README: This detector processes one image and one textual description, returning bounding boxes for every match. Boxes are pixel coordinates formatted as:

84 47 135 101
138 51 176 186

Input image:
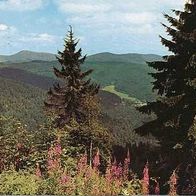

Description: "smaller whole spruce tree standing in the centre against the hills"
45 27 99 127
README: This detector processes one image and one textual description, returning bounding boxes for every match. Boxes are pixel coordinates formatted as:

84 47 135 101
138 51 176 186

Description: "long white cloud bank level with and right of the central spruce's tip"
68 12 160 36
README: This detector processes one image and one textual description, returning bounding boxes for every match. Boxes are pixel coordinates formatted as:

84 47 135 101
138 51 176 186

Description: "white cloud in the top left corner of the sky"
0 0 43 11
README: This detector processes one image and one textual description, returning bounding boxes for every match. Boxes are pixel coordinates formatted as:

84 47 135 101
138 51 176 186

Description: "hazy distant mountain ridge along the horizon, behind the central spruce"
0 50 161 64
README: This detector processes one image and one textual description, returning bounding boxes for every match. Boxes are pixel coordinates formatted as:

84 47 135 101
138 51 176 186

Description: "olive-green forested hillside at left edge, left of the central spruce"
0 77 46 130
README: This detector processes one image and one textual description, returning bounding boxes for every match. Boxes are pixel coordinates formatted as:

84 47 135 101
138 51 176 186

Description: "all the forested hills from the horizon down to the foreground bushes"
0 51 158 145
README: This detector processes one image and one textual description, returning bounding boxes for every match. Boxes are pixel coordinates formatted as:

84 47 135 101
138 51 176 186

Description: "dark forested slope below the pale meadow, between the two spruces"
102 96 157 147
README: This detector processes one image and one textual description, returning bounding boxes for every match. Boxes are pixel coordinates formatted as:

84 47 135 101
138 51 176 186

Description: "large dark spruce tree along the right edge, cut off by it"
137 0 196 193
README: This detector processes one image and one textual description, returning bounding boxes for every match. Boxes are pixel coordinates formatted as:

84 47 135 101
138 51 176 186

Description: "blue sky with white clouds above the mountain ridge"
0 0 185 55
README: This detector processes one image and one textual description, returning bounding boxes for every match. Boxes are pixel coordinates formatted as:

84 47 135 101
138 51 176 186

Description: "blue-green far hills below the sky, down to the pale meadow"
0 51 161 102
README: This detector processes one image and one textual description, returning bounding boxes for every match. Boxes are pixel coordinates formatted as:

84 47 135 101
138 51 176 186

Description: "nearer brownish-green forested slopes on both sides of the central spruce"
0 74 154 145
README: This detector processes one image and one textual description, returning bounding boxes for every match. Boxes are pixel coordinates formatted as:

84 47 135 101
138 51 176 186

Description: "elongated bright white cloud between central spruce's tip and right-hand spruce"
69 12 159 33
